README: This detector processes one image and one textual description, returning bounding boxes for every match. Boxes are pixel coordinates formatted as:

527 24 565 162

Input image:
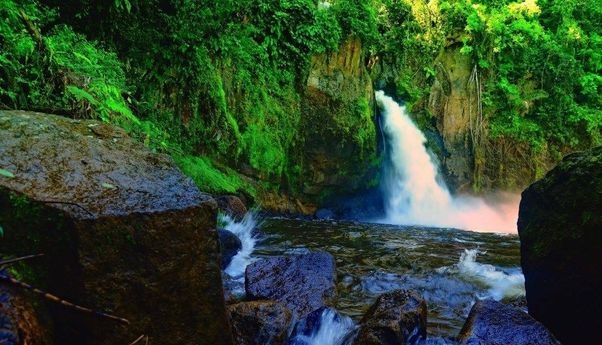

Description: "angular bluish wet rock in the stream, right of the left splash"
245 252 336 318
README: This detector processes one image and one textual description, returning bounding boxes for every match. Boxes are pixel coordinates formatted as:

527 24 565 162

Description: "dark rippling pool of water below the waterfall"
253 219 524 338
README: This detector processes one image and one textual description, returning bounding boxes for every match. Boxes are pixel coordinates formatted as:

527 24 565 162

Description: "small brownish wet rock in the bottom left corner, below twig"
0 271 53 345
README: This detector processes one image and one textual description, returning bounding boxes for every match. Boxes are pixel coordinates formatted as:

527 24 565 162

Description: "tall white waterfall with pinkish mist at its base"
376 91 518 232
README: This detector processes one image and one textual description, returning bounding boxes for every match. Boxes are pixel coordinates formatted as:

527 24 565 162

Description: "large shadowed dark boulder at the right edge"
518 147 602 344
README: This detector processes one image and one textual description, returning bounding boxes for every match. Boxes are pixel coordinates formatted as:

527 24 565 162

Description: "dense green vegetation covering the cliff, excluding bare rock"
0 0 602 199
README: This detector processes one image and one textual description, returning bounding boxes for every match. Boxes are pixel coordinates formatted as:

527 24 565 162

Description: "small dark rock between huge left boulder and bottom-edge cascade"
228 301 292 345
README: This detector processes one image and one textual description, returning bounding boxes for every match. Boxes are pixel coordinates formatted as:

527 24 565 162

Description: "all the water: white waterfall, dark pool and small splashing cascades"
221 91 525 345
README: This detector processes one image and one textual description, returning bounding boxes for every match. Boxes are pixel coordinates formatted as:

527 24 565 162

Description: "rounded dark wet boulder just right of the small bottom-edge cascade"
354 290 427 345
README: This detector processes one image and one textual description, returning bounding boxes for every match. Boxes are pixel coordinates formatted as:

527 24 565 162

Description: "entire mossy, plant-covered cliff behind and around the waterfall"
0 0 602 213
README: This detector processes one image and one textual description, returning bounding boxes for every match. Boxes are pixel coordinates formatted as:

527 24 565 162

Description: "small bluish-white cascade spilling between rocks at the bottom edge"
286 307 355 345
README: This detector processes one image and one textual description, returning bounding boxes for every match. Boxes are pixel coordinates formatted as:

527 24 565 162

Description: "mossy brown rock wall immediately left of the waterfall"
299 37 377 200
